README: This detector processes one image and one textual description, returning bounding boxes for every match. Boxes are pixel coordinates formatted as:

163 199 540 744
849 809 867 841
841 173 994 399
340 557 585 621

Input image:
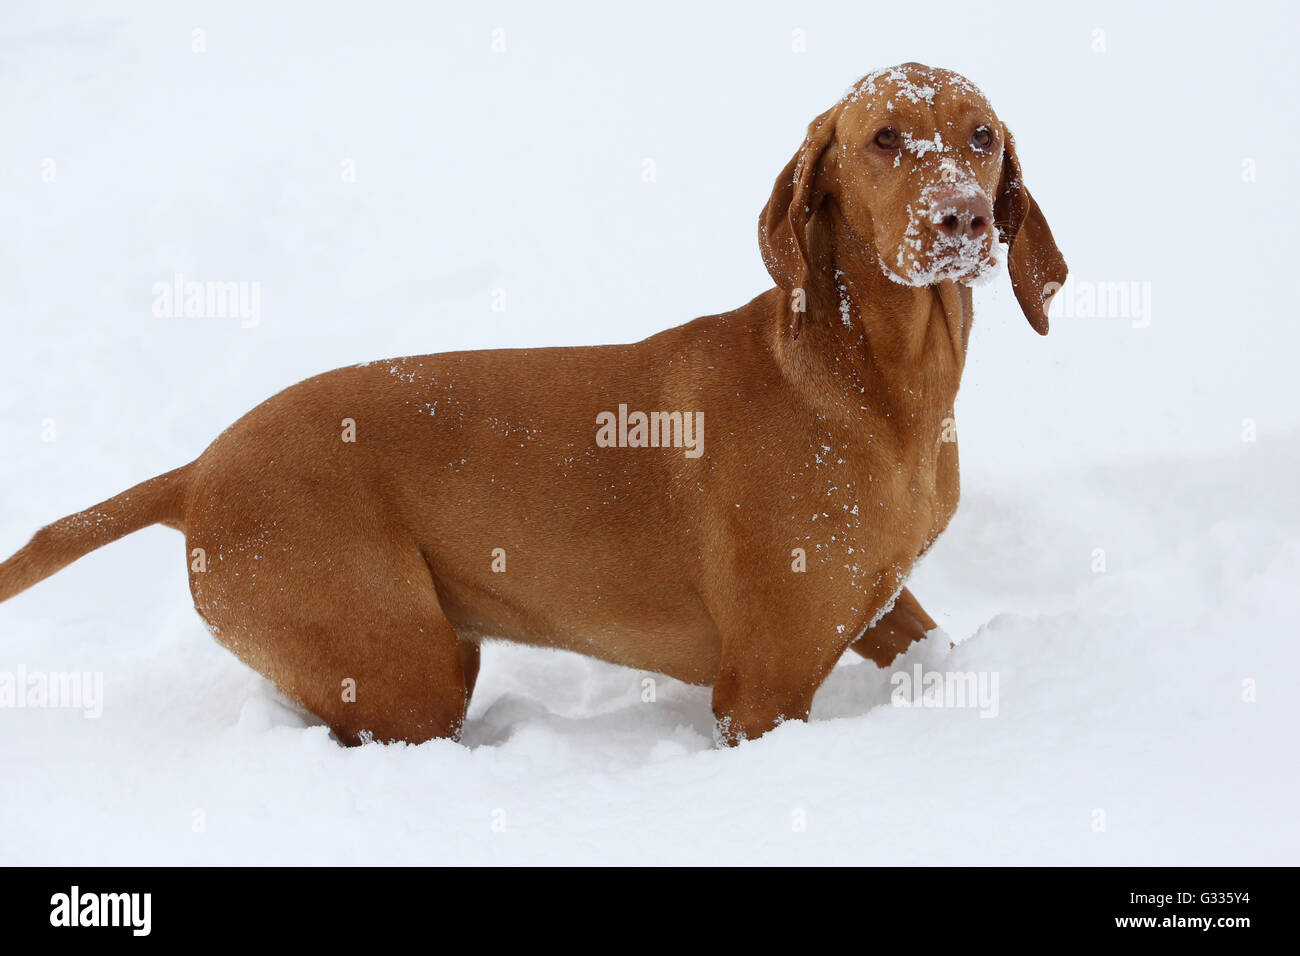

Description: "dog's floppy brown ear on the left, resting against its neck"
758 104 840 337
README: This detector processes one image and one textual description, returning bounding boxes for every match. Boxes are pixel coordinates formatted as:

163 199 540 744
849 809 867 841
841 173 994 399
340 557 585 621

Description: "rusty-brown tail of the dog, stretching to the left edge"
0 464 191 601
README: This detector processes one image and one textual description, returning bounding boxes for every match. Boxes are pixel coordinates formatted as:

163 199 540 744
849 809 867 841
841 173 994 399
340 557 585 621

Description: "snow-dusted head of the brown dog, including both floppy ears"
758 64 1066 334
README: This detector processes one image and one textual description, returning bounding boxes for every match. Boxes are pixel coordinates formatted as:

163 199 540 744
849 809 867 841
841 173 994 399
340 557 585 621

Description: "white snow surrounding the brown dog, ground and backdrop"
0 0 1300 865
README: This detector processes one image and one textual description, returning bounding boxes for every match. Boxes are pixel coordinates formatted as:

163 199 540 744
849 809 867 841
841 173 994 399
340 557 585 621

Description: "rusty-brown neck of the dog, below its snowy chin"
774 200 972 442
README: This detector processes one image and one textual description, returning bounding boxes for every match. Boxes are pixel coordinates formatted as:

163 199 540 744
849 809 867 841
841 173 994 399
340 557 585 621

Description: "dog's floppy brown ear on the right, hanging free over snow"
993 127 1070 336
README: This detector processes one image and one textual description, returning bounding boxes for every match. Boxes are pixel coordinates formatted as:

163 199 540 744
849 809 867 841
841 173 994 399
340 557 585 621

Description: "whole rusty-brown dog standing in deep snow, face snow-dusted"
0 64 1066 743
